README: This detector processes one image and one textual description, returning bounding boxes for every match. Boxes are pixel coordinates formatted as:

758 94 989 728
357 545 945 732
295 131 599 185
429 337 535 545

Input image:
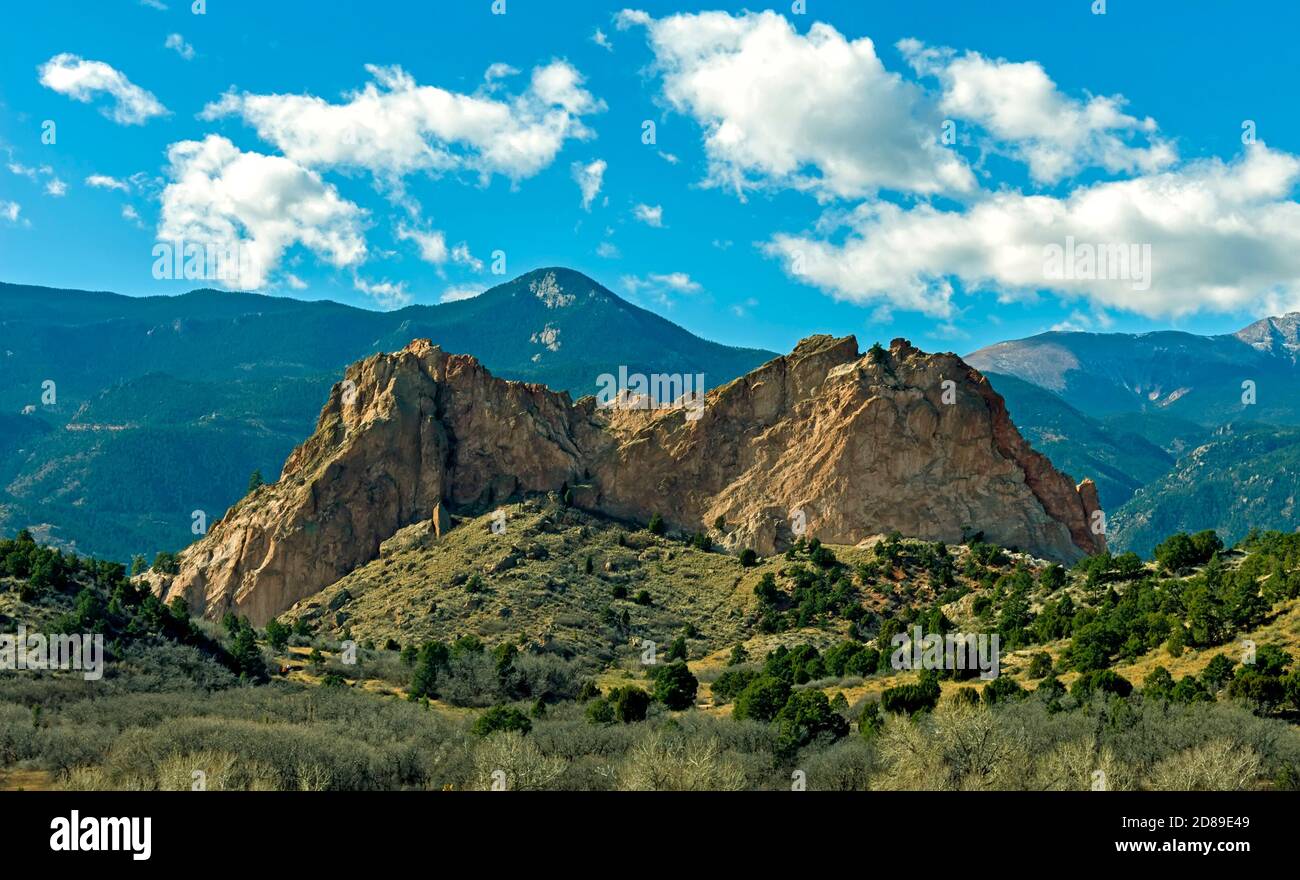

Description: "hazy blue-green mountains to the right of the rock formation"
966 312 1300 554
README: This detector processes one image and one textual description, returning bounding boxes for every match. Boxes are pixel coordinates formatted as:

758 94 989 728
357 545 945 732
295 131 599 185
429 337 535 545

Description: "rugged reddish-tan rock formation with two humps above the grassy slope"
151 337 1105 624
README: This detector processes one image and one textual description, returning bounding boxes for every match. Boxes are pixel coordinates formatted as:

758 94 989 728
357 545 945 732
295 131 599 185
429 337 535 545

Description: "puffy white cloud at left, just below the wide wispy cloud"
159 135 367 287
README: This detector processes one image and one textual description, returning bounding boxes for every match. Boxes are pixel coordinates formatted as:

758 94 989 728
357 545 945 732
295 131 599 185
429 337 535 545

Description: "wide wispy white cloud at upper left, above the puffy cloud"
202 61 605 185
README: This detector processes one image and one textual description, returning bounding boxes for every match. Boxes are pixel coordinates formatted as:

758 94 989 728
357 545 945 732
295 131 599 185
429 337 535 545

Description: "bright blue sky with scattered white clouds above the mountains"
0 0 1300 352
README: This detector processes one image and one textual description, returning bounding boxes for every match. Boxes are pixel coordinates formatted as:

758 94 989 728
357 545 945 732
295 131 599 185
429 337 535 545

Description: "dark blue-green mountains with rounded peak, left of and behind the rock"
0 268 775 559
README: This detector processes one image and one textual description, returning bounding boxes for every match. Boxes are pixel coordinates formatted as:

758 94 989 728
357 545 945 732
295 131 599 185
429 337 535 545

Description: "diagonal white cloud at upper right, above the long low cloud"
898 39 1178 183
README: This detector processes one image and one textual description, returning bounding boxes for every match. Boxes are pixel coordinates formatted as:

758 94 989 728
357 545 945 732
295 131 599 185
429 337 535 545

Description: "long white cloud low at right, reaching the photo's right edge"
764 144 1300 317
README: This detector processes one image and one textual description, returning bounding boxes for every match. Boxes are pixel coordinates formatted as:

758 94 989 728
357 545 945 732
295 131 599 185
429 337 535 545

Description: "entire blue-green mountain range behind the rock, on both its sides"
0 268 1300 559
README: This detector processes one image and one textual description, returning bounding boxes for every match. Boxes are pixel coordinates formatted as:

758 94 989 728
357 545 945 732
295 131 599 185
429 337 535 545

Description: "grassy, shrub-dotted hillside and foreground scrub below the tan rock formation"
10 499 1300 790
